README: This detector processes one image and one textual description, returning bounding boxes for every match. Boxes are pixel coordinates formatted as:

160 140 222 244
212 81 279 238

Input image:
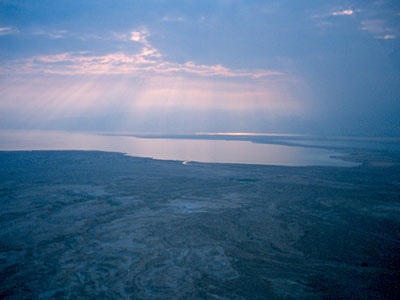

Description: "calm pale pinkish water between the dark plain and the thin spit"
0 130 355 166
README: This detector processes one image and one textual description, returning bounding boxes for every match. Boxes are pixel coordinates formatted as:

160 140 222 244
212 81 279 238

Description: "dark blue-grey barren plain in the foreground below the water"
0 151 400 300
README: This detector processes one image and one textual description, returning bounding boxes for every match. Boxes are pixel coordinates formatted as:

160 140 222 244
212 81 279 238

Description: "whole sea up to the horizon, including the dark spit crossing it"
0 130 400 167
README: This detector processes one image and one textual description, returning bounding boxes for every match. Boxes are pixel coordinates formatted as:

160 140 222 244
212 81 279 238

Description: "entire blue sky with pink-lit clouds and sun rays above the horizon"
0 0 400 136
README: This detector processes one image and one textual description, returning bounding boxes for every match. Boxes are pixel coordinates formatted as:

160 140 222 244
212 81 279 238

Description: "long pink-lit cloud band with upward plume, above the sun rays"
0 31 286 80
